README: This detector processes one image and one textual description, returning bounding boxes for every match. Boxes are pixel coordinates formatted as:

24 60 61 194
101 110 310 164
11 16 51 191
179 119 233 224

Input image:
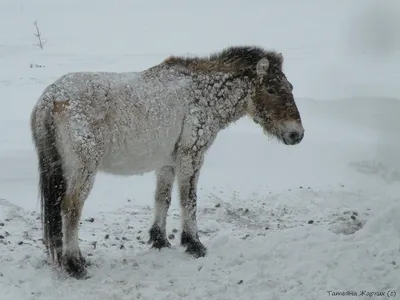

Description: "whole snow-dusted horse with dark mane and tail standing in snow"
31 47 304 278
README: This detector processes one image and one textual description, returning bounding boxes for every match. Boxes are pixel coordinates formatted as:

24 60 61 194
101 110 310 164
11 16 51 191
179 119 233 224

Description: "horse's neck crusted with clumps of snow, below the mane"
193 73 253 128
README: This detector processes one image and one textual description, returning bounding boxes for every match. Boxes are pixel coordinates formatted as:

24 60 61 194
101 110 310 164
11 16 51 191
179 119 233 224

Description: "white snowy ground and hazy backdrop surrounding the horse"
0 0 400 300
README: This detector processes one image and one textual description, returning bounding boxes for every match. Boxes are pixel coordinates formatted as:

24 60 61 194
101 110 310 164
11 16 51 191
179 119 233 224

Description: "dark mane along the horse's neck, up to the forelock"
164 46 282 77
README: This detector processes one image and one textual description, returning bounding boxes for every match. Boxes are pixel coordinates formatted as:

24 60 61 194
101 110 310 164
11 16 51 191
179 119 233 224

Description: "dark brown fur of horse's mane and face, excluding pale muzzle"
164 46 301 142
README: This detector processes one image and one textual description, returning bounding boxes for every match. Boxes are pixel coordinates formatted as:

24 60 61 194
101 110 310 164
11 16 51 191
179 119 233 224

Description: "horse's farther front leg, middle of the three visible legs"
149 166 175 249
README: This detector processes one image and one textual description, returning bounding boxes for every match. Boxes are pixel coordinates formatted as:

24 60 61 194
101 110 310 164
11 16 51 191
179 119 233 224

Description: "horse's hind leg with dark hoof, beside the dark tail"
61 126 103 278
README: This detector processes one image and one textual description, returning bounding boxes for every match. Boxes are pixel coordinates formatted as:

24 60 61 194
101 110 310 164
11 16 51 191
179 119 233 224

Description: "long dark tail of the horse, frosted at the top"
31 96 67 263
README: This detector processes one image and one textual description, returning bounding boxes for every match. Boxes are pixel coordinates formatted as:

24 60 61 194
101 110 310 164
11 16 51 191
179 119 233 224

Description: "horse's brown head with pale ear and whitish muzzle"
248 53 304 145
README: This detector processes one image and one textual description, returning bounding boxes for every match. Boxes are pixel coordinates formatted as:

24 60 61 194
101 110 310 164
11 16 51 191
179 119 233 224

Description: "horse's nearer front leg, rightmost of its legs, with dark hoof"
177 148 207 257
